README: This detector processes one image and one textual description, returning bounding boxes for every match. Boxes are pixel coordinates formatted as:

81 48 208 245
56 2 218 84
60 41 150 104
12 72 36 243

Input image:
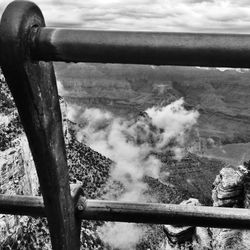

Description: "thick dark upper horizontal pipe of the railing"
31 28 250 68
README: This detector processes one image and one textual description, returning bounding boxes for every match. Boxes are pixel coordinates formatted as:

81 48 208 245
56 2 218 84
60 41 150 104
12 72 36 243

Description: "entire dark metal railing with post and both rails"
0 1 250 250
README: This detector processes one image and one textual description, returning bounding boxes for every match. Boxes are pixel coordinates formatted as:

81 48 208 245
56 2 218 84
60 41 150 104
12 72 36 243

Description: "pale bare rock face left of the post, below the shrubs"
0 135 39 241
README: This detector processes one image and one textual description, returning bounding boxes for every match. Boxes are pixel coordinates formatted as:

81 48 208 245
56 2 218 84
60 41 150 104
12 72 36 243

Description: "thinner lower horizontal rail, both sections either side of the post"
0 195 250 229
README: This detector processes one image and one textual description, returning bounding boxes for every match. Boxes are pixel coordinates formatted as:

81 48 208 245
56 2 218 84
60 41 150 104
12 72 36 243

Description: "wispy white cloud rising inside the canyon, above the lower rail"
72 99 199 201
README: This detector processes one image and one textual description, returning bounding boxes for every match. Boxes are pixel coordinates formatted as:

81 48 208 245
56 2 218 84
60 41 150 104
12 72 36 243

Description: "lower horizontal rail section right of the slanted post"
79 200 250 229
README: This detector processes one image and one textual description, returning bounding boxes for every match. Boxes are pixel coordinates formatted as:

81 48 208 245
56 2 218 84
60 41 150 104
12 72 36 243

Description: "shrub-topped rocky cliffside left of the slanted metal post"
0 69 39 243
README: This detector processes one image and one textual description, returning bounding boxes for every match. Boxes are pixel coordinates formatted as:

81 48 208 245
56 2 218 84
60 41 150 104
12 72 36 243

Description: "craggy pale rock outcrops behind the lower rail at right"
163 164 250 250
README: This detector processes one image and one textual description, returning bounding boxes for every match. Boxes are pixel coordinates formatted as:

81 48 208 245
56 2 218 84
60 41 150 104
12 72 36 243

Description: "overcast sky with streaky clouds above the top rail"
0 0 250 33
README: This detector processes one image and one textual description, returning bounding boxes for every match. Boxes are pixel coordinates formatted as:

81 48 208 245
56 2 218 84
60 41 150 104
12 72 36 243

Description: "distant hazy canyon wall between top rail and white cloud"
56 64 250 143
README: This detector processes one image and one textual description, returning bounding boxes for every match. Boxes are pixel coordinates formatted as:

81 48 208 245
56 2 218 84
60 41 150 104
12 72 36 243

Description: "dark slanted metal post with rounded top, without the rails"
0 1 80 250
